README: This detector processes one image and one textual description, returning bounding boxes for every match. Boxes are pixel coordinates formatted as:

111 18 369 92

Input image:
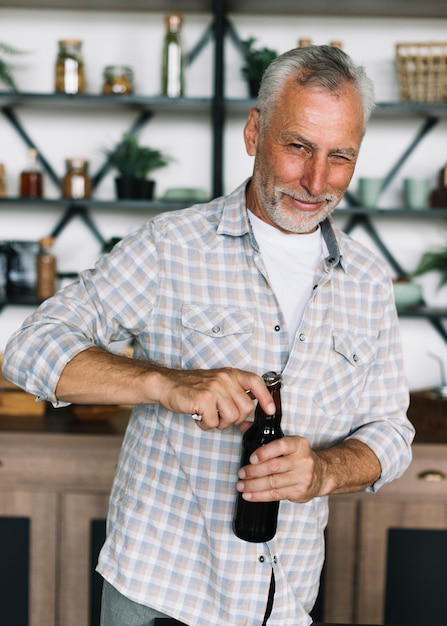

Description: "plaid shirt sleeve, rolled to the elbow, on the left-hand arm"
3 227 157 407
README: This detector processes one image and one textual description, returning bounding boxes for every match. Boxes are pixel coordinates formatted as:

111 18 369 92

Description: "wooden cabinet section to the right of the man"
324 444 447 626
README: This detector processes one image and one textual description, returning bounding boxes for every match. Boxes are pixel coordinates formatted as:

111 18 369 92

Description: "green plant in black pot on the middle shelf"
105 133 170 199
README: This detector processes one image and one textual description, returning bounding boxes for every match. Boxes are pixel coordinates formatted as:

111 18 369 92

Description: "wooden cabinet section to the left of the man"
0 410 128 626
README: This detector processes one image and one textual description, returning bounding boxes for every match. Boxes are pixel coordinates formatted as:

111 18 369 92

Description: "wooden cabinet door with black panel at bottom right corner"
354 496 447 624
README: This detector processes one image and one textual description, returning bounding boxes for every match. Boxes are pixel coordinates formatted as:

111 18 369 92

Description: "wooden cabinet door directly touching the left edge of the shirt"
58 493 109 626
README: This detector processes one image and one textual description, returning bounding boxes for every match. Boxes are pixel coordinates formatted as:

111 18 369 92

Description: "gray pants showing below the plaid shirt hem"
101 580 186 626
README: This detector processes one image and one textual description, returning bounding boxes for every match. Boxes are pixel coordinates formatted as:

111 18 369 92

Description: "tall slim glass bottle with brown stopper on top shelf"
161 13 184 98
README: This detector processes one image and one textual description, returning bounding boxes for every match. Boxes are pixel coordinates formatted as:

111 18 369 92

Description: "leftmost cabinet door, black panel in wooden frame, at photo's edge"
0 490 57 626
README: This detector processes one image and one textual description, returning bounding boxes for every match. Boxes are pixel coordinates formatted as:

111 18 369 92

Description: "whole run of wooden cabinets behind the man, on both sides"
0 401 447 626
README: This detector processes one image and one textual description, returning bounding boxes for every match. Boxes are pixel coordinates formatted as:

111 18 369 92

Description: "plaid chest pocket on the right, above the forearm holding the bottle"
314 334 377 415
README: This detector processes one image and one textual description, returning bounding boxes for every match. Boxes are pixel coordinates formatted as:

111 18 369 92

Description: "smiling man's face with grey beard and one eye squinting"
244 79 363 233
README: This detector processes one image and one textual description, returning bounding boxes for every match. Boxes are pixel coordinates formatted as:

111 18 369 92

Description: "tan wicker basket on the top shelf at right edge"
396 43 447 102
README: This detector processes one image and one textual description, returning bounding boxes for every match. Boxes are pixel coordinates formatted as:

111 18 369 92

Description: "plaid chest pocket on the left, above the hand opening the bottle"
182 305 253 369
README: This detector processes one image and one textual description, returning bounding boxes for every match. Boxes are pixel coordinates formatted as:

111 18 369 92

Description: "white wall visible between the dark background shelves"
0 9 447 389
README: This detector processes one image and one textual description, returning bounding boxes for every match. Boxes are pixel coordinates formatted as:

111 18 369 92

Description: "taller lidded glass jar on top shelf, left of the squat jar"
54 39 86 94
